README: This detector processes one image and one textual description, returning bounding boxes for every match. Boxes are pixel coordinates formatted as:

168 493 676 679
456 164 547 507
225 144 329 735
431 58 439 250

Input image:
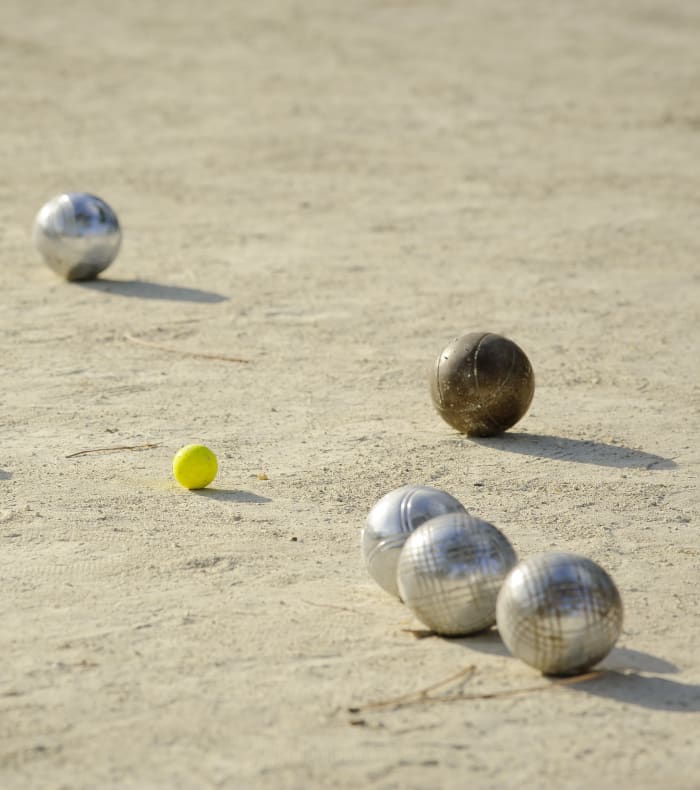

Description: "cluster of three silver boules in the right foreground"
362 486 622 675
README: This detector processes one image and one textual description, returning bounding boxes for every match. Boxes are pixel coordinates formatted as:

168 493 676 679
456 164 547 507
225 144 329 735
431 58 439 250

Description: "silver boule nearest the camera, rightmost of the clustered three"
496 552 622 675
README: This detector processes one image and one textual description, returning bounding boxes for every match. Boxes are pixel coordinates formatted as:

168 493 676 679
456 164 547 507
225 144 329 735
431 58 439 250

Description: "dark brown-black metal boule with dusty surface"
430 332 535 436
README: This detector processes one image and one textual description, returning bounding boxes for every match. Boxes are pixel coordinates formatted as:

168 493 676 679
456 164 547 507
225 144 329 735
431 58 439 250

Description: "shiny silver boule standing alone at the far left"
34 192 122 280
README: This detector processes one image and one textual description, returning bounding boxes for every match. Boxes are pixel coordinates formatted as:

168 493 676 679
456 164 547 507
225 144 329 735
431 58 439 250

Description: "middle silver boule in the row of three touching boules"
397 513 517 636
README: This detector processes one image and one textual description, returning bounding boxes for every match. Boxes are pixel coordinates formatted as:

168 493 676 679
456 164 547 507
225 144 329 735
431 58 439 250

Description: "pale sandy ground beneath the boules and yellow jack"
0 0 700 790
